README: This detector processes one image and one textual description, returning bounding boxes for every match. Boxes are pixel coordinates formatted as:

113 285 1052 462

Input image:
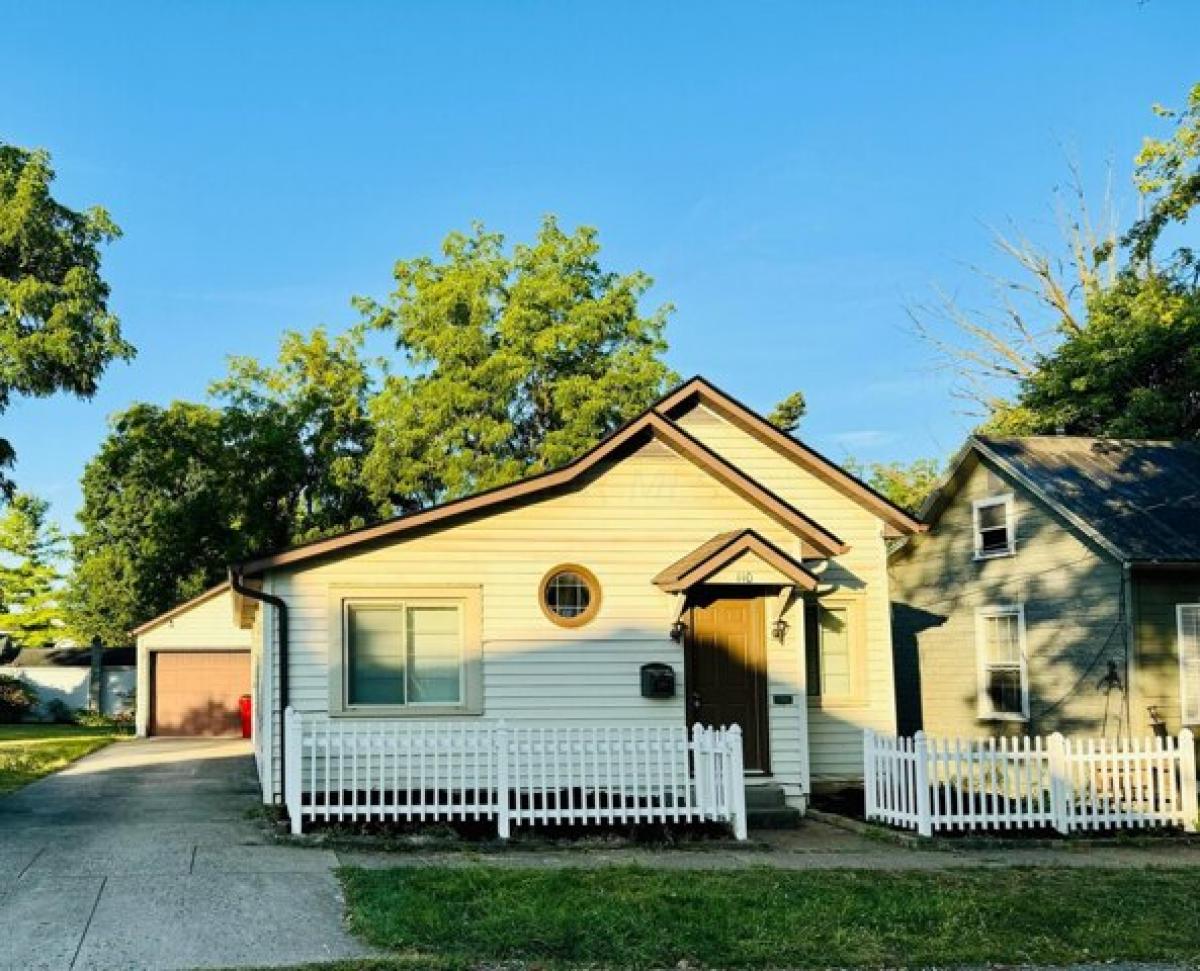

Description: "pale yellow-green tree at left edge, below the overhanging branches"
0 492 65 647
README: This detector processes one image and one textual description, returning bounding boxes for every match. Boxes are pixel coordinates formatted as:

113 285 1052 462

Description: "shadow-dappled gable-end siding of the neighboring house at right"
890 457 1132 737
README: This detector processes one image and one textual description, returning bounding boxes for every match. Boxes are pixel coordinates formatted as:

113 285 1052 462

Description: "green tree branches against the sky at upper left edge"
0 142 133 496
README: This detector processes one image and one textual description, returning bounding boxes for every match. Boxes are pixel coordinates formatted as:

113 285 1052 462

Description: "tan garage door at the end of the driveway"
150 651 250 735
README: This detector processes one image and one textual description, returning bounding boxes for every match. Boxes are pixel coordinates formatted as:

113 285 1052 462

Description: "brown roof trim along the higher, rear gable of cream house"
655 376 928 535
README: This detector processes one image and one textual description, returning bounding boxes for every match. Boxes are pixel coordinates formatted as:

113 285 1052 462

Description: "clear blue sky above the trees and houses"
0 0 1200 530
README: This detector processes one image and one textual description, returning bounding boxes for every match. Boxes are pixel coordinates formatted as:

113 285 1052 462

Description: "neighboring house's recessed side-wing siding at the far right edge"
1133 570 1200 735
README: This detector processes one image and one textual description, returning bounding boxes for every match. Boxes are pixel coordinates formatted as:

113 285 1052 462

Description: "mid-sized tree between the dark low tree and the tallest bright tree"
211 328 382 543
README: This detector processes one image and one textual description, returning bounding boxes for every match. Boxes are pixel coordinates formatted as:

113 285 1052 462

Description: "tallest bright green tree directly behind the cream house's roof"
358 217 674 509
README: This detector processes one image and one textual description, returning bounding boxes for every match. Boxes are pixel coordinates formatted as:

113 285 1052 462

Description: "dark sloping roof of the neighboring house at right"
973 436 1200 564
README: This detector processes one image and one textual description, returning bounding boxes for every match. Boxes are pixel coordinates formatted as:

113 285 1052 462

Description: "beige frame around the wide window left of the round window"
329 583 484 718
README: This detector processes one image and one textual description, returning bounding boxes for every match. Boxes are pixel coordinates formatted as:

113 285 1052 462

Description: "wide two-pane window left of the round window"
330 583 480 715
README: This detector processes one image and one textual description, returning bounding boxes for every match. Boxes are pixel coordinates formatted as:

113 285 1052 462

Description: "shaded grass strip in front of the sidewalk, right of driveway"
320 867 1200 971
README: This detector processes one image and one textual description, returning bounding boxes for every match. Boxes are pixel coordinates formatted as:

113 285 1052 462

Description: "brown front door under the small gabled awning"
684 587 770 772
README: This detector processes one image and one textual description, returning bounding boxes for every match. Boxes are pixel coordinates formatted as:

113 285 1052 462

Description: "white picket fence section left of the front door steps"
284 708 746 839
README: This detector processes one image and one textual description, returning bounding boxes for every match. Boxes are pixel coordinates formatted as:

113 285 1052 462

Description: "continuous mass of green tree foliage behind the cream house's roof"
68 218 673 643
